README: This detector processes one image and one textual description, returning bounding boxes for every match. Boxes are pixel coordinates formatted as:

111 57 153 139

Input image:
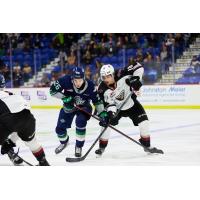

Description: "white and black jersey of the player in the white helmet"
98 62 144 112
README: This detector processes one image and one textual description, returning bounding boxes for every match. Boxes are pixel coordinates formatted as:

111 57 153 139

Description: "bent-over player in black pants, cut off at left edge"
0 77 49 166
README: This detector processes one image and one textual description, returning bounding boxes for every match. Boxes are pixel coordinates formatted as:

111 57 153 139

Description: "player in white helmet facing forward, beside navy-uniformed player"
95 62 160 155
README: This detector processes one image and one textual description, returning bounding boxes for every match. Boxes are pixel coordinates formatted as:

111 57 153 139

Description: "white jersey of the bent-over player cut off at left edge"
0 91 30 115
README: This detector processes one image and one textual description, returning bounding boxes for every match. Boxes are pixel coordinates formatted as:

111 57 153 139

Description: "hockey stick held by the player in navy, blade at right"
76 99 164 154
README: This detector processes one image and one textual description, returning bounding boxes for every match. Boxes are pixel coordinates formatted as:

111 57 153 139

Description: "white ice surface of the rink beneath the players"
0 109 200 166
